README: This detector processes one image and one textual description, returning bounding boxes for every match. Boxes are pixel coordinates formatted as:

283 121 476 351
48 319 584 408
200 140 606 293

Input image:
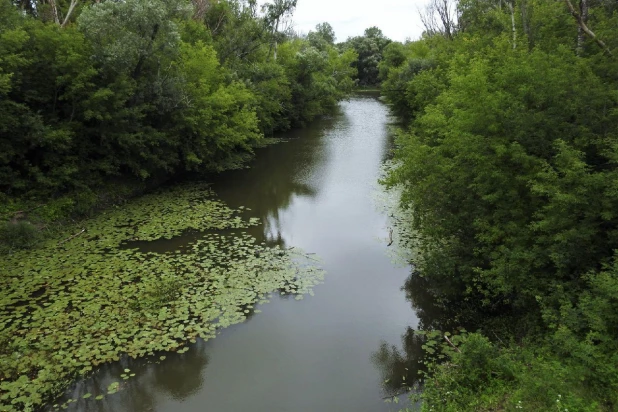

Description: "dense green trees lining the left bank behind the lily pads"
0 0 356 225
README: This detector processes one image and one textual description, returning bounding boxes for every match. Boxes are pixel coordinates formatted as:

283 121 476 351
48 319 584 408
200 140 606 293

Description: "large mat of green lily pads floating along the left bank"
0 185 323 411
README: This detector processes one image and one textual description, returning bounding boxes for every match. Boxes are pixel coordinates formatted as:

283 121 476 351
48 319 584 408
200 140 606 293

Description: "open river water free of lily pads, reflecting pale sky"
54 96 417 412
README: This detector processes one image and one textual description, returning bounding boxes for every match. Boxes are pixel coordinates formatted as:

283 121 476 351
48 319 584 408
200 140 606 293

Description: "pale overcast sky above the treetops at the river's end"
294 0 427 42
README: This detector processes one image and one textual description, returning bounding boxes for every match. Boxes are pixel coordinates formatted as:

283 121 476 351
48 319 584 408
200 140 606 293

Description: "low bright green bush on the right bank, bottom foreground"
421 333 603 412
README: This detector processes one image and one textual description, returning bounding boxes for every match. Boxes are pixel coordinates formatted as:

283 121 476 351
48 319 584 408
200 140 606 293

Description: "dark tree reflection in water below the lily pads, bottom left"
49 340 208 412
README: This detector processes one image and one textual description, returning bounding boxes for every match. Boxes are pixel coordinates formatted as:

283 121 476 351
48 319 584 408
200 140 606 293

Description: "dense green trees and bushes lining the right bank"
380 0 618 411
